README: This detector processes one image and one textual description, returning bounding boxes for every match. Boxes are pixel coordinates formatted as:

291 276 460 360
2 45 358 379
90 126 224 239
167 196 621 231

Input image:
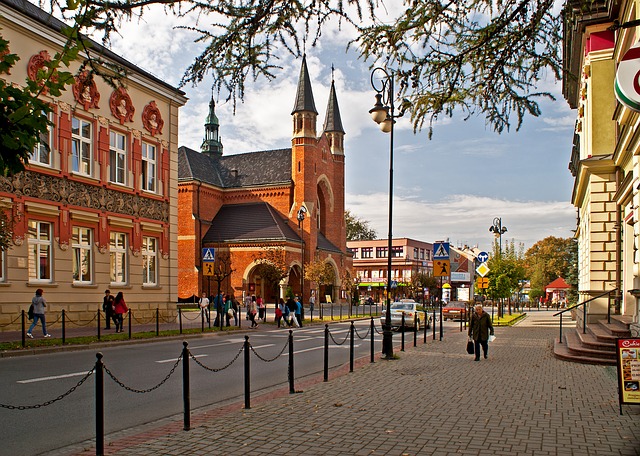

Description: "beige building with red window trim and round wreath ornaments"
0 0 187 329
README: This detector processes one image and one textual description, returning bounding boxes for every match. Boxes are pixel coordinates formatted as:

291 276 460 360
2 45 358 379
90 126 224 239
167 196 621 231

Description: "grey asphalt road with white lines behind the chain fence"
0 320 459 455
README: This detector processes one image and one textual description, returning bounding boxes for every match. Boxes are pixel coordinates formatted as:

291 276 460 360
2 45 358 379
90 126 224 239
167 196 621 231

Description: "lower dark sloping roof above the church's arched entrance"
202 202 300 243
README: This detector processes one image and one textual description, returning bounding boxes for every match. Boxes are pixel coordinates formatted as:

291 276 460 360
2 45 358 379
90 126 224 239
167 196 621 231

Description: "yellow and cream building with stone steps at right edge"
563 1 640 334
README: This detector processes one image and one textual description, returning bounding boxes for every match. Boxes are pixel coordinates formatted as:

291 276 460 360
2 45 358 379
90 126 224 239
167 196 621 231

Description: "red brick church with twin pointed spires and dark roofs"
178 58 352 302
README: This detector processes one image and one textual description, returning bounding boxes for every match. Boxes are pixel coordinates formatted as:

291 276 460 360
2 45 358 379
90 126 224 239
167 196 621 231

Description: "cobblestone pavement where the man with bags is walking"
58 312 640 456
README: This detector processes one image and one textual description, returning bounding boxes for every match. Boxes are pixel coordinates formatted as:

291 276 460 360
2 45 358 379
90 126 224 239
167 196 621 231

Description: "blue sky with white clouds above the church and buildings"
104 3 576 252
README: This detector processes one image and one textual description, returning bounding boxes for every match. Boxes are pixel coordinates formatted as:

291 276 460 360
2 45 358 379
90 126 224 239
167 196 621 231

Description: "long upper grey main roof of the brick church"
178 146 291 188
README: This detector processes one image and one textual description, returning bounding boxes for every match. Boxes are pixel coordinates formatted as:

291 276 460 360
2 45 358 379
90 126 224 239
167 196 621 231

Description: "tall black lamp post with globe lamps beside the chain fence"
369 67 404 359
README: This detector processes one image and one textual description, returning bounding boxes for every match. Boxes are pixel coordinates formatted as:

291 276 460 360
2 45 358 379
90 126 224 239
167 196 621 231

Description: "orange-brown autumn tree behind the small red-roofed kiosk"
524 236 578 302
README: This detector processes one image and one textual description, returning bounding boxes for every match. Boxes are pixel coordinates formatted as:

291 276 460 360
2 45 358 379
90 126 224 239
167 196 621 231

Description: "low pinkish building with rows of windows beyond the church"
347 238 433 302
